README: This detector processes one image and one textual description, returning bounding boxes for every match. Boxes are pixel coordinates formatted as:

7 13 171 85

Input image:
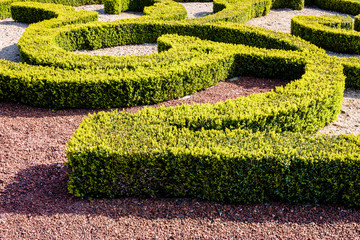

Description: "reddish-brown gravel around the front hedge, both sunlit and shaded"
0 78 360 239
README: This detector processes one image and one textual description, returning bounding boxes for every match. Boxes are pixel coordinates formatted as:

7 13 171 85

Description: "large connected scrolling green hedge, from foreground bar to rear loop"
0 0 360 206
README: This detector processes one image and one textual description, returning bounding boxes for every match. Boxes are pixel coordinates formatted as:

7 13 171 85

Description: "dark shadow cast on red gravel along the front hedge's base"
0 164 360 224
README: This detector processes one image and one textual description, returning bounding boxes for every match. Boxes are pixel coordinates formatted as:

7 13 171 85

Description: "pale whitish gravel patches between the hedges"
0 3 360 134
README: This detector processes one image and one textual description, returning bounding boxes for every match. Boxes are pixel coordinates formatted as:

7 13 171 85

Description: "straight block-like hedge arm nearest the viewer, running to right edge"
66 114 360 206
